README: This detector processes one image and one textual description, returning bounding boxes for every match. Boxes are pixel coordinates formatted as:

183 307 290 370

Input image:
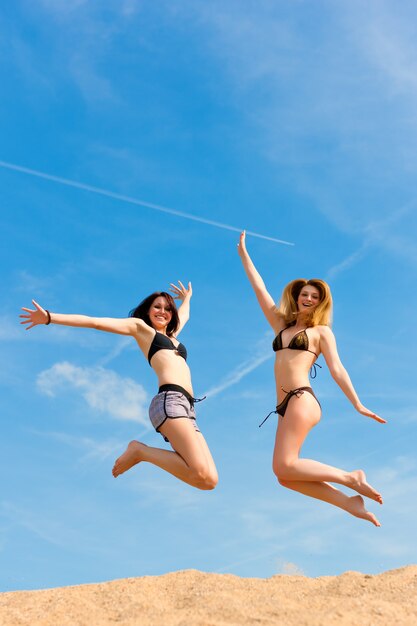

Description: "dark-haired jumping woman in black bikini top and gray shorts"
20 281 218 490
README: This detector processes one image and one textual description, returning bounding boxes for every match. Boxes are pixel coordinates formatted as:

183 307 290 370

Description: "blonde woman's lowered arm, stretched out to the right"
320 326 386 424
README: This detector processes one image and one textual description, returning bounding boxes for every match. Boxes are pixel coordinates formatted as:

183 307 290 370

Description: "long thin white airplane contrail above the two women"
0 161 295 246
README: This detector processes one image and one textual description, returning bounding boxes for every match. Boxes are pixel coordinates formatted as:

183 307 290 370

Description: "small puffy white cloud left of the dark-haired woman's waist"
37 361 148 426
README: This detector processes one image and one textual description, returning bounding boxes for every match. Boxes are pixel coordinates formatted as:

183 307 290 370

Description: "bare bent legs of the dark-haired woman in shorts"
113 417 218 490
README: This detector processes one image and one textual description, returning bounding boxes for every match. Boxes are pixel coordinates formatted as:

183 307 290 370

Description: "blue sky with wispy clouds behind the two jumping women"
0 0 417 590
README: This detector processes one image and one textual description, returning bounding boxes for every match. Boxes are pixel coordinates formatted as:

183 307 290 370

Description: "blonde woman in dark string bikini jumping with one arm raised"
238 232 385 526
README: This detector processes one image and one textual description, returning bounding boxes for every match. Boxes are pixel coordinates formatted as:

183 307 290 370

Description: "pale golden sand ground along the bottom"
0 565 417 626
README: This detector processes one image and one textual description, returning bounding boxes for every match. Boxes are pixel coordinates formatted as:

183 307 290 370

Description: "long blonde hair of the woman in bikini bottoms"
277 278 333 326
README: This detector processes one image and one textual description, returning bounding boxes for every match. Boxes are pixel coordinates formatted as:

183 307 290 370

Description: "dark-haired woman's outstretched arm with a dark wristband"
20 300 141 335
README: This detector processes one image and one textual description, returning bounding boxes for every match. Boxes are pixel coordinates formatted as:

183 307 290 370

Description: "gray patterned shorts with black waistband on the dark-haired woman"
149 385 200 441
